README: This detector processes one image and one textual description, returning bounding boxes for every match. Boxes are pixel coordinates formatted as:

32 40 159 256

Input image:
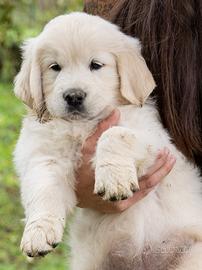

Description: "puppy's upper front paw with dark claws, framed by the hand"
94 162 139 201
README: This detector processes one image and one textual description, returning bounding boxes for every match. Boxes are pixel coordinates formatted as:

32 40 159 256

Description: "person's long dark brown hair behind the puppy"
85 0 202 168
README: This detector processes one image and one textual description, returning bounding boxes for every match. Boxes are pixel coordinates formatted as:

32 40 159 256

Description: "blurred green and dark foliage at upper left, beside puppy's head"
0 0 83 81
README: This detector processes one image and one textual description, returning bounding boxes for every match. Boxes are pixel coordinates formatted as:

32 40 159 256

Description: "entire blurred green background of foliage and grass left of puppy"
0 0 83 270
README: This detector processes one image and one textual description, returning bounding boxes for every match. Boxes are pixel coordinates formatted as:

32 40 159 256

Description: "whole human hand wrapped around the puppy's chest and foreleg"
76 110 176 213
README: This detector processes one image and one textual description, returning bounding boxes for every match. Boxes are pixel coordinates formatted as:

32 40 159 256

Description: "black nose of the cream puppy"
63 89 86 108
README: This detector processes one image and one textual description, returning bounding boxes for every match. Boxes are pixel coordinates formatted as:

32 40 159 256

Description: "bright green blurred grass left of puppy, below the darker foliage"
0 84 67 270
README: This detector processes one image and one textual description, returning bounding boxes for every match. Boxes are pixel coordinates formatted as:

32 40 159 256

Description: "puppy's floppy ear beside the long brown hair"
117 36 156 105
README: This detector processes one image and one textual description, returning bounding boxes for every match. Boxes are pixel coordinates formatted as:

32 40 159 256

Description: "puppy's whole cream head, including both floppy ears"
15 13 155 120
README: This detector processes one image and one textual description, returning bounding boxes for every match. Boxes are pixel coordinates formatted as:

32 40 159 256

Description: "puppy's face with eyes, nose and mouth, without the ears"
40 40 119 120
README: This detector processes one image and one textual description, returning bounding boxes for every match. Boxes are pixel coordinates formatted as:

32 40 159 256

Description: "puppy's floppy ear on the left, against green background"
14 38 43 112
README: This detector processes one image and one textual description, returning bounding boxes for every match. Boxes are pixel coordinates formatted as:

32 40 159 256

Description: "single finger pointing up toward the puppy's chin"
82 109 120 155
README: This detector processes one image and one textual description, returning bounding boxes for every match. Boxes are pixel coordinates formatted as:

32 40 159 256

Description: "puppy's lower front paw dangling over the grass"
21 216 64 257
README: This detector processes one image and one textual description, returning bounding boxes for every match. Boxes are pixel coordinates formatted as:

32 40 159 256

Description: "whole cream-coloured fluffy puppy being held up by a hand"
15 13 202 270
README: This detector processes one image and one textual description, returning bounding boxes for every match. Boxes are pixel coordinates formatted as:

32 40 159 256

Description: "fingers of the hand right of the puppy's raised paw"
139 149 176 190
